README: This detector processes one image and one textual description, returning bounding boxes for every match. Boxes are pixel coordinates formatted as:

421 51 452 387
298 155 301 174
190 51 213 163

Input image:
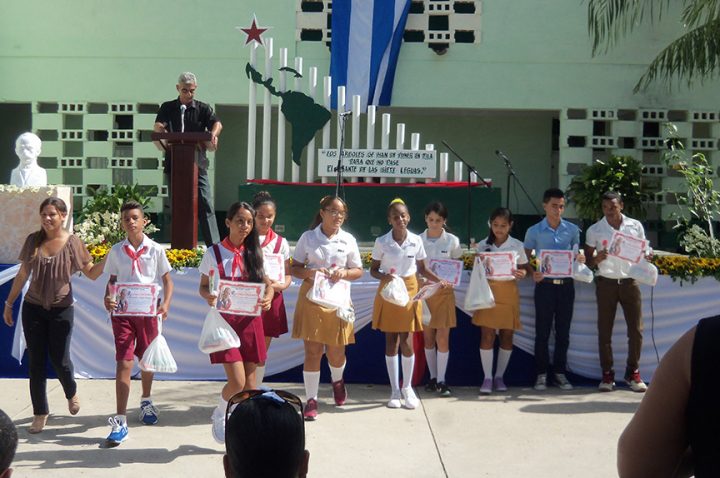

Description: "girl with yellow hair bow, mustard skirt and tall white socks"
370 199 448 409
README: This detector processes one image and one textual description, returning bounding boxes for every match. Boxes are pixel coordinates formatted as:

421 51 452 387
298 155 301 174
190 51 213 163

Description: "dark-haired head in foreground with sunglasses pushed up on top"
223 390 310 478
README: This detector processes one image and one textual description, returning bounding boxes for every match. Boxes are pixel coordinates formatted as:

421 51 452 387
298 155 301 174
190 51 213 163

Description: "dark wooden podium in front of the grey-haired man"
150 132 212 249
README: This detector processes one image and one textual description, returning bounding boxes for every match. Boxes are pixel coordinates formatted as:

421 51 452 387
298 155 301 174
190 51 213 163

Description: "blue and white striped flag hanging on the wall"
330 0 410 111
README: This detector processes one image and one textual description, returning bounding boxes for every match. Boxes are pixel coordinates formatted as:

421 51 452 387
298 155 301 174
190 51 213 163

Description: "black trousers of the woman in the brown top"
23 302 77 415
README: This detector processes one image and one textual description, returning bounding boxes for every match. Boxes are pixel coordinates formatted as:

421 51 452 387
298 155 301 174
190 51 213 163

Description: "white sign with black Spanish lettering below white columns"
318 149 437 178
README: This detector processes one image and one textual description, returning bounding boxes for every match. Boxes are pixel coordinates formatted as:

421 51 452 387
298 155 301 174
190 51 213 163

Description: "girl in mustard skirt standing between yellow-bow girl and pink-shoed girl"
420 202 462 397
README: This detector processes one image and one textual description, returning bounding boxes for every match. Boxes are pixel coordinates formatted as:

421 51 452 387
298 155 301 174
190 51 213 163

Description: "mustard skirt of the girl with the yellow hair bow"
373 274 422 333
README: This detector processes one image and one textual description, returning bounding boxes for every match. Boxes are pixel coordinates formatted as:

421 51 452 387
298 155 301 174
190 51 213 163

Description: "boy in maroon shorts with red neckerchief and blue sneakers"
105 201 173 444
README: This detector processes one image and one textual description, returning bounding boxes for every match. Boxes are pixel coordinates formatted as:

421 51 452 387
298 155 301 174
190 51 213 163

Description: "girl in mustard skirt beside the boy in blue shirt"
472 207 528 395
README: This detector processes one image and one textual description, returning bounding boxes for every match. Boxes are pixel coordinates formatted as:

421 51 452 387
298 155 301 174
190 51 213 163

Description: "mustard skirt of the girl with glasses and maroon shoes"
293 279 355 345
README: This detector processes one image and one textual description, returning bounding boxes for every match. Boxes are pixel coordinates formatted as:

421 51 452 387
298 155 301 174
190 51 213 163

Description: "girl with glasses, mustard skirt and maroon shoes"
290 196 363 420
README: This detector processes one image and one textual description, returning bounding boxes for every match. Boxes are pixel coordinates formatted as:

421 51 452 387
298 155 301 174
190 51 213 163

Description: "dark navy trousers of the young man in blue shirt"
535 279 575 374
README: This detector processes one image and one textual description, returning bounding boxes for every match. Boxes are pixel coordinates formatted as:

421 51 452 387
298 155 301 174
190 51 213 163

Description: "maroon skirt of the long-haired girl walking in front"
210 312 267 363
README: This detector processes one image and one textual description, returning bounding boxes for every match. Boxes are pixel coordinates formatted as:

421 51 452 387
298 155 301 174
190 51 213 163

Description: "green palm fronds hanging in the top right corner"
588 0 720 93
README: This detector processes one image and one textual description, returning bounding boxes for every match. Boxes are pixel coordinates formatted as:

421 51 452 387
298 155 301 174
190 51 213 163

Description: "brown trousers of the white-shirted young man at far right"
595 277 643 377
